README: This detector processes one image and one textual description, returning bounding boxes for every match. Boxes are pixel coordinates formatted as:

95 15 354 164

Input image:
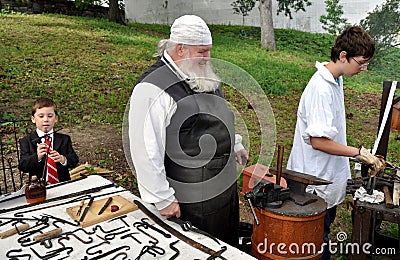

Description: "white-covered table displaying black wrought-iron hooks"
0 175 255 259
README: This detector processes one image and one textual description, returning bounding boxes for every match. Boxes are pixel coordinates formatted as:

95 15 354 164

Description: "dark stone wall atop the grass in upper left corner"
0 0 119 18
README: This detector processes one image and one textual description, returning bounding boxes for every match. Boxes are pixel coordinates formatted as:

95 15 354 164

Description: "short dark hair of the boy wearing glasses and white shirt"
331 26 375 62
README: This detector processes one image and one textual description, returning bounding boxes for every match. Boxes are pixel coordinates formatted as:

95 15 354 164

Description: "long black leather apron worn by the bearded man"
138 60 239 246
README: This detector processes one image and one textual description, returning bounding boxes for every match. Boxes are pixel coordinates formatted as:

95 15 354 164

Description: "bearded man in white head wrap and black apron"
129 15 248 246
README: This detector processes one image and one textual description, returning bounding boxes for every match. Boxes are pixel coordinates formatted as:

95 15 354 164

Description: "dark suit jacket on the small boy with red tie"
18 131 79 182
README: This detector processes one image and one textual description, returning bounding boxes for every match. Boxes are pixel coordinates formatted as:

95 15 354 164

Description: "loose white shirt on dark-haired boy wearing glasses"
287 62 351 208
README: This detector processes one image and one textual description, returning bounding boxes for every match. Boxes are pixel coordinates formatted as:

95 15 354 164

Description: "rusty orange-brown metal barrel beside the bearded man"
251 196 326 259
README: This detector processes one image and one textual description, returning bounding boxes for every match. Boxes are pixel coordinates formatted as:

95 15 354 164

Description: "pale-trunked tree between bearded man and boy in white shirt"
238 0 311 51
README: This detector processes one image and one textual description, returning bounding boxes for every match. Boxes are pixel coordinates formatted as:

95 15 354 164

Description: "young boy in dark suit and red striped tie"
18 98 79 184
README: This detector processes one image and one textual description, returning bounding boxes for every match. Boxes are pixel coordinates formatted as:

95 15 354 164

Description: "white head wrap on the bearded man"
169 15 212 45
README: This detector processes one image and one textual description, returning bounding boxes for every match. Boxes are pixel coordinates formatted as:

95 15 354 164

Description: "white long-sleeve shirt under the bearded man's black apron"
128 52 244 210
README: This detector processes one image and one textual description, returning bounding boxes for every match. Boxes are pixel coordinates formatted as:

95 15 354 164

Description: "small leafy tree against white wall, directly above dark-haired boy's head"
319 0 348 35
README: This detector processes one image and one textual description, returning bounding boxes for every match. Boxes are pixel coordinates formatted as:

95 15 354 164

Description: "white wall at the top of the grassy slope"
125 0 385 32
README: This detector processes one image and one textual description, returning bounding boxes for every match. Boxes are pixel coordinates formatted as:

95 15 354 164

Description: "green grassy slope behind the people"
0 13 400 258
